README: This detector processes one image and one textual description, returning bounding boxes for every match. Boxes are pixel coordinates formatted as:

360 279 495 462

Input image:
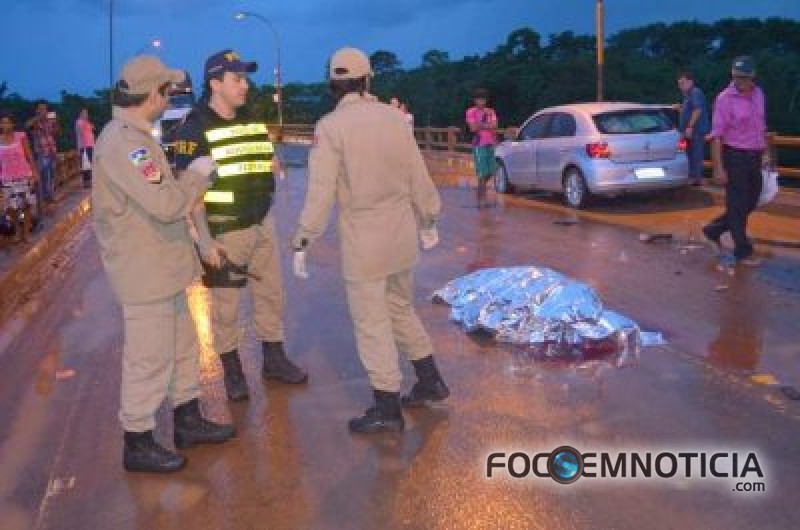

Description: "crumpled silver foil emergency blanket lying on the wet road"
433 267 663 367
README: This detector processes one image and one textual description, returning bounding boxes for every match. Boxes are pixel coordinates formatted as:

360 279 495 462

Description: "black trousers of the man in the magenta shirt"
703 146 763 259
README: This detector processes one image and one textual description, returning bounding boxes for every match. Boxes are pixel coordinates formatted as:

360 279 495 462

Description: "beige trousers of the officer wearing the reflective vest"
211 214 285 354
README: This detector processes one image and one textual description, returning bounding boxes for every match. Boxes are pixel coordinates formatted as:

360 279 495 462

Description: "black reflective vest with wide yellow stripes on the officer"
204 122 275 235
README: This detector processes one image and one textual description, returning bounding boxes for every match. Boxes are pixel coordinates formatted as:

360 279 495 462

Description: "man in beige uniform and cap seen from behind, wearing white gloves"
292 48 449 433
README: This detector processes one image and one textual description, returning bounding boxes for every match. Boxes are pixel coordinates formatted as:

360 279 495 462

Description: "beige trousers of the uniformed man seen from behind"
345 270 433 392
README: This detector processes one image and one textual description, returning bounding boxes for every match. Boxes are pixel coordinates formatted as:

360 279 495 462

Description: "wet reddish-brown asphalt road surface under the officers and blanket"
0 150 800 529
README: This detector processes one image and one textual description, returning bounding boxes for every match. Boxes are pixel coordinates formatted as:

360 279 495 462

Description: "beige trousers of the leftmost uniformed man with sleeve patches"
119 292 200 432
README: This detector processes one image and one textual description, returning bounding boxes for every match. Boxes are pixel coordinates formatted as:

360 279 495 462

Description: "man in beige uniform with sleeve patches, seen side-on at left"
92 56 234 472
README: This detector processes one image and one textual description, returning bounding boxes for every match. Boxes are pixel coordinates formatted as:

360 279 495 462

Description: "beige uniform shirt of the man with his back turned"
293 94 441 280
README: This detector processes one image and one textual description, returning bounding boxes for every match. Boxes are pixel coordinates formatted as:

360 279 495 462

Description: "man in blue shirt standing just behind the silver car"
678 72 710 186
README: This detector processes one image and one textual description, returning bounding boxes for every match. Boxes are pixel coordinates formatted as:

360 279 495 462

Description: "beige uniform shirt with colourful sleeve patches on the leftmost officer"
92 108 209 304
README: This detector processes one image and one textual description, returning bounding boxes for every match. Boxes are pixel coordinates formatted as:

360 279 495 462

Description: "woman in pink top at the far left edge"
0 112 39 239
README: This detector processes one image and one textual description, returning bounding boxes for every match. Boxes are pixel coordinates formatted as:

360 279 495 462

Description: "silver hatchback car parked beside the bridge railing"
494 103 689 208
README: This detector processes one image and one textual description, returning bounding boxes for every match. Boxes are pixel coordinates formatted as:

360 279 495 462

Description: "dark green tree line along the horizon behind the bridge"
0 18 800 146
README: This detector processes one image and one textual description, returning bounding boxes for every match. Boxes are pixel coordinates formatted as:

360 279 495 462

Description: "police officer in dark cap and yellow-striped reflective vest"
175 50 307 401
